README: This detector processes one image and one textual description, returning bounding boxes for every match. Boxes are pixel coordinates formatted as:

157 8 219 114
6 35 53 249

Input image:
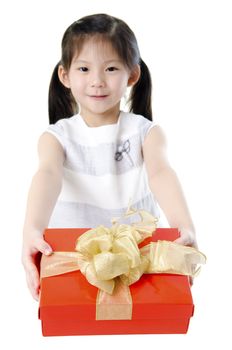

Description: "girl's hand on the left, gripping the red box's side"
22 235 52 301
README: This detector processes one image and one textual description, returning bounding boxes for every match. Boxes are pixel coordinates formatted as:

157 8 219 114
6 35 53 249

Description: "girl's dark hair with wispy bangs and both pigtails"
49 14 152 124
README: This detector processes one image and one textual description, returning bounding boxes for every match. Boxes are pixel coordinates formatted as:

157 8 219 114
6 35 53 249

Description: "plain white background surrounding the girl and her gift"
0 0 232 350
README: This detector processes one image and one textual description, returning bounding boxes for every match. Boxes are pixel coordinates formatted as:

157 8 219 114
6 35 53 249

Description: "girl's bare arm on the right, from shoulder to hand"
143 126 197 247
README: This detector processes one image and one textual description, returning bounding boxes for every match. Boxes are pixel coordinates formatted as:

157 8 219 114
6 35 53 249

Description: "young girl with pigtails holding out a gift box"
22 14 196 300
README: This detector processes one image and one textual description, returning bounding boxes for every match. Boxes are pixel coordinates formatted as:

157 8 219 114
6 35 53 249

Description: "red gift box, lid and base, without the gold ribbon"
39 228 194 336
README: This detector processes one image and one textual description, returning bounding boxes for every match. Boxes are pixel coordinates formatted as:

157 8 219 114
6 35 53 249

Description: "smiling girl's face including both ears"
59 38 140 123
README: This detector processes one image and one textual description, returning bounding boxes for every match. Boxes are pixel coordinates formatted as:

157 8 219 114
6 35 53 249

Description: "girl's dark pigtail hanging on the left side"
48 62 77 124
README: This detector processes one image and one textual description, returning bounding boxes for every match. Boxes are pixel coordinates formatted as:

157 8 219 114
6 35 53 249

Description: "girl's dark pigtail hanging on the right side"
129 59 152 120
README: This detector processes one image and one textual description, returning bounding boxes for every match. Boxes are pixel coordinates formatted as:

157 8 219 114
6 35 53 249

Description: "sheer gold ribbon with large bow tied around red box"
41 208 206 320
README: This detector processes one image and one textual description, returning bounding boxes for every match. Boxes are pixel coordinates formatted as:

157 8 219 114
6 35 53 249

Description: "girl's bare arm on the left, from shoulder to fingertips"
22 132 64 300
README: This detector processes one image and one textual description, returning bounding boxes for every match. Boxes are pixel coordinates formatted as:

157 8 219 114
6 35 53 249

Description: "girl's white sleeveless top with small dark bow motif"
46 112 159 228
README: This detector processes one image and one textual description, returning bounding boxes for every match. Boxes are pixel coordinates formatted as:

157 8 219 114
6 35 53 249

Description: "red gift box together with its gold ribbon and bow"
39 208 205 336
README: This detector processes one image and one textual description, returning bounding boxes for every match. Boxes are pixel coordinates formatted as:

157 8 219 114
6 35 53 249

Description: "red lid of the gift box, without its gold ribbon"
39 228 193 320
